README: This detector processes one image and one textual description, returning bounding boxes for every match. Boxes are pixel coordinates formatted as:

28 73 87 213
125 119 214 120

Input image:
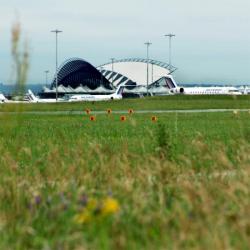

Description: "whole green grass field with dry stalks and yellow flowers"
0 97 250 249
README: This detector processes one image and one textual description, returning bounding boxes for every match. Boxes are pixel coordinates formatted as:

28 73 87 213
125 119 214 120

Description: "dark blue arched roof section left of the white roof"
51 58 112 89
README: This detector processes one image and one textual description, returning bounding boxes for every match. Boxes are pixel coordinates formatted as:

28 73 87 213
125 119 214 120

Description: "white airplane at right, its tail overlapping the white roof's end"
167 75 242 95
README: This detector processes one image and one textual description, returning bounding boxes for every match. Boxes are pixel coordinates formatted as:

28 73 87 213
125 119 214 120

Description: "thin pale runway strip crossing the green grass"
0 109 250 115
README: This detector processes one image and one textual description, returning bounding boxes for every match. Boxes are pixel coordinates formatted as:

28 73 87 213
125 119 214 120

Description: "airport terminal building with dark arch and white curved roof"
41 58 176 97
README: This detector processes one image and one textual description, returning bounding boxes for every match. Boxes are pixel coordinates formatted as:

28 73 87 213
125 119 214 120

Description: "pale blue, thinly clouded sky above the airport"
0 0 250 84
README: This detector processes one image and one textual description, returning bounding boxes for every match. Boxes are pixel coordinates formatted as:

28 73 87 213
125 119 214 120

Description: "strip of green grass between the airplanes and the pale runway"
0 95 250 112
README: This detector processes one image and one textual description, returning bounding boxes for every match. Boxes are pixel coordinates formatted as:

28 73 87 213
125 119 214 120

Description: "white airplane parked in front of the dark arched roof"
69 85 125 102
